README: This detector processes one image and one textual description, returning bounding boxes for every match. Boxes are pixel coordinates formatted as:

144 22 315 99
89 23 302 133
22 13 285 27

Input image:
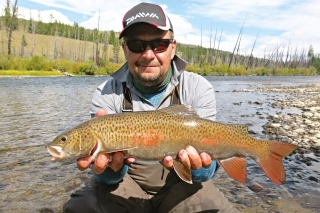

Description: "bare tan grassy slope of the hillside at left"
0 30 124 62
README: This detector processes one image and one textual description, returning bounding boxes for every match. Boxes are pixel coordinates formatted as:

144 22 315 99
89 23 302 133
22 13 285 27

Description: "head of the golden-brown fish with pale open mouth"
46 125 97 162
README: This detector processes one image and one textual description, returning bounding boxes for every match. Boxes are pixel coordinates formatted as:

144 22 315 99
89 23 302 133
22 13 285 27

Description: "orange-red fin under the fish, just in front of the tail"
219 157 247 183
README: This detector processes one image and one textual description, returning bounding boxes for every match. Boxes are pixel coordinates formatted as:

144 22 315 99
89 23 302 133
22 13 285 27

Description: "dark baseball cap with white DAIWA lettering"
119 3 173 39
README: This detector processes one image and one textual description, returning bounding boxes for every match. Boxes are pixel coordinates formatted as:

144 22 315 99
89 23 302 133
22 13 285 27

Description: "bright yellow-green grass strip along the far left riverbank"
0 70 63 77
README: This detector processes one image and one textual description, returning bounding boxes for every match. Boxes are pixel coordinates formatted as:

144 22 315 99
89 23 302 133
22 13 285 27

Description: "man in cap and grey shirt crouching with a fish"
64 3 236 212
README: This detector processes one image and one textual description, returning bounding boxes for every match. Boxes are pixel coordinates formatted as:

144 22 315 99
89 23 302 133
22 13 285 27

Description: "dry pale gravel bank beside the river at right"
260 84 320 151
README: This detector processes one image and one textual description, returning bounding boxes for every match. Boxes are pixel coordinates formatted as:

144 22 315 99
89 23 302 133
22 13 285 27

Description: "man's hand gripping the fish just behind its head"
77 109 135 174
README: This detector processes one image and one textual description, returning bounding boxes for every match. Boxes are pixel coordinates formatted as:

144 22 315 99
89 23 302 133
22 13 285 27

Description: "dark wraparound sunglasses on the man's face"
124 39 173 53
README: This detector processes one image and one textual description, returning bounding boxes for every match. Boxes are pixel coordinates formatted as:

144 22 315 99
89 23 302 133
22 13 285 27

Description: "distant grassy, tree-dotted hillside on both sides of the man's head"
0 16 320 74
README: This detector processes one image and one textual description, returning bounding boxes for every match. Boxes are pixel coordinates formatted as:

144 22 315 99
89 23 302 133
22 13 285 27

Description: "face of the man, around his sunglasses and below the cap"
122 24 176 87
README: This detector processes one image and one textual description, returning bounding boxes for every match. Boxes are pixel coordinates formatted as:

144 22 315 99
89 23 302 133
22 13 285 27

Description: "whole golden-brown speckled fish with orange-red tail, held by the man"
46 105 297 184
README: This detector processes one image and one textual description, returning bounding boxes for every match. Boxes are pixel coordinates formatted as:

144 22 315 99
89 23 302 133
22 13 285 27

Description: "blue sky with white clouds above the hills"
0 0 320 57
